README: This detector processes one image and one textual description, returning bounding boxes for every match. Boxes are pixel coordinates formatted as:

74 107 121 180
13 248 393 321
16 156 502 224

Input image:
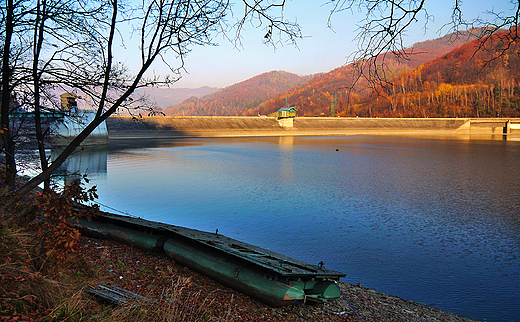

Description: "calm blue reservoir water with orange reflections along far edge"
69 136 520 321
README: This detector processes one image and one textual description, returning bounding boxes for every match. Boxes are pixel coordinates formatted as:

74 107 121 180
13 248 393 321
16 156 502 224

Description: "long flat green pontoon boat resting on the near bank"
77 213 345 306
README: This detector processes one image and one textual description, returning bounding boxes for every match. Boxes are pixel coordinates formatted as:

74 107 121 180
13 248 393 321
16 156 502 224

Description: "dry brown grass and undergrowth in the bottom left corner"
0 187 233 322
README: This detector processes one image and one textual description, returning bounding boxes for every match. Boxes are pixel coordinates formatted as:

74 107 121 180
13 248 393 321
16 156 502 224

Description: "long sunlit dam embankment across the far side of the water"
106 116 520 139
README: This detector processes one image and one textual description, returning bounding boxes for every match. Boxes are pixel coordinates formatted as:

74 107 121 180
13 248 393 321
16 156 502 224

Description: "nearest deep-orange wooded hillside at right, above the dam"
356 26 520 117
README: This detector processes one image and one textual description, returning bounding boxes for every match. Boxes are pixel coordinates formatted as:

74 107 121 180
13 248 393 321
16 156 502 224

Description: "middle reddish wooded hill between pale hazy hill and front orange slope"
252 32 475 116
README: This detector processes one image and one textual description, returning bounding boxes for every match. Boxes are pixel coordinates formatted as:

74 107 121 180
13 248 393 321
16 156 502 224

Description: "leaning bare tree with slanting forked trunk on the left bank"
10 0 299 194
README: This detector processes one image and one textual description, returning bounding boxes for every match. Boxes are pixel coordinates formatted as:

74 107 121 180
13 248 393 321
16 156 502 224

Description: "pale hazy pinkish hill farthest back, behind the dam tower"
163 71 312 116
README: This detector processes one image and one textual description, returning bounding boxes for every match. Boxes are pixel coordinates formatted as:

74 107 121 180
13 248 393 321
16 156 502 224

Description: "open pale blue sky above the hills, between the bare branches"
121 0 513 88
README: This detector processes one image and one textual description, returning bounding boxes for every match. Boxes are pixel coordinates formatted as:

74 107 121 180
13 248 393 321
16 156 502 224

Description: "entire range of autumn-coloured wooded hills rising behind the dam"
164 30 520 117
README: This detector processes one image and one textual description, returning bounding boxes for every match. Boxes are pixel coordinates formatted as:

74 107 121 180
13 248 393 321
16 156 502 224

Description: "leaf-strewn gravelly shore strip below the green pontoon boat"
80 236 476 322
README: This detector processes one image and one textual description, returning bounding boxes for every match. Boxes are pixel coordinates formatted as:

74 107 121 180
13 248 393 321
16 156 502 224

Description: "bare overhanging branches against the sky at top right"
326 0 520 85
